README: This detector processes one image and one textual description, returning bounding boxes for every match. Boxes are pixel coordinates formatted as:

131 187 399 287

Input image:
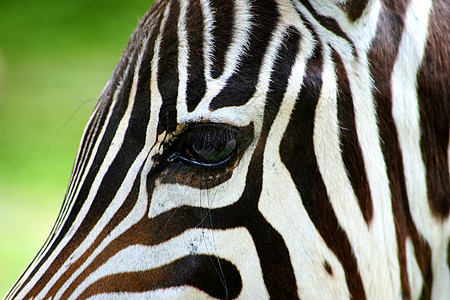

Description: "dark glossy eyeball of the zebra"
178 124 238 167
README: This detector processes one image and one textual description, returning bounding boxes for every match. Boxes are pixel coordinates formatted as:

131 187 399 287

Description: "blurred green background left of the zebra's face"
0 0 154 298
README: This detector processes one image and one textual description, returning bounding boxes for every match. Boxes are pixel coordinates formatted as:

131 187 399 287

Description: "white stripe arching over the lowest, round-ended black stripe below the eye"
71 228 269 299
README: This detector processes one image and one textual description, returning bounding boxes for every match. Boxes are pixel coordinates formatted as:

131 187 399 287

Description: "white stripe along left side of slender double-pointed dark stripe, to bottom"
314 43 401 299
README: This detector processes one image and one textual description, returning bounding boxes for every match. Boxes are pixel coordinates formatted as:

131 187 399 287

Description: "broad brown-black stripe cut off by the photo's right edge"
417 1 450 220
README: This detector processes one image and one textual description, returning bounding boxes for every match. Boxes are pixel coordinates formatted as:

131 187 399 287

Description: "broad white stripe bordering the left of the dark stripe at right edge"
392 0 450 299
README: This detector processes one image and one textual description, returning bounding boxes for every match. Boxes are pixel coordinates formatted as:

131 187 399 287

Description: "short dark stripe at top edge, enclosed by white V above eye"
210 0 235 78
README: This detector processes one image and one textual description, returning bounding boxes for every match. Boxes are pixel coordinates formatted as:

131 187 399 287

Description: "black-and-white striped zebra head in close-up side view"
6 0 450 299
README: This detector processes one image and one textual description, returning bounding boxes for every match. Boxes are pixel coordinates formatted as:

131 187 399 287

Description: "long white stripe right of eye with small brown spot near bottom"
258 10 349 299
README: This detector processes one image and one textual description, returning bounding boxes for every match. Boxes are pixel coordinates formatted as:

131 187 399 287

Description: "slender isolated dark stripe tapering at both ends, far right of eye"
332 51 373 224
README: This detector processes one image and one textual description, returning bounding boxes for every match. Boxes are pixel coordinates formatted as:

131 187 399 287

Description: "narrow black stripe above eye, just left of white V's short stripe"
186 0 206 112
